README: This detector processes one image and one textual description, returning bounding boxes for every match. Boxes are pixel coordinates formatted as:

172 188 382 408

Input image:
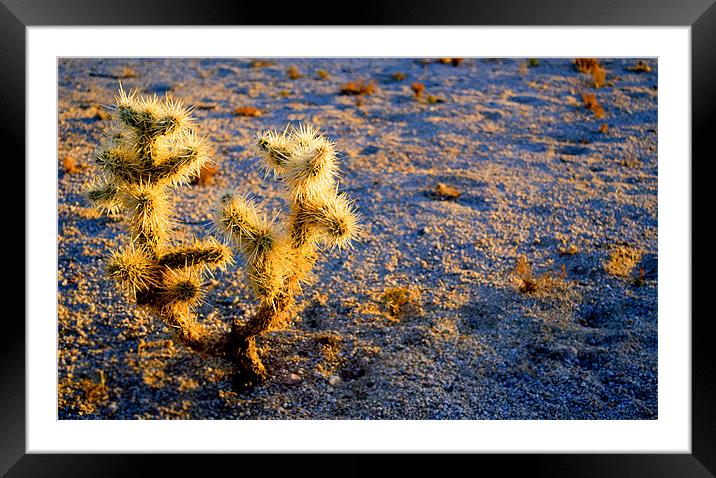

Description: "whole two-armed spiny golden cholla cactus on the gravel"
88 86 360 388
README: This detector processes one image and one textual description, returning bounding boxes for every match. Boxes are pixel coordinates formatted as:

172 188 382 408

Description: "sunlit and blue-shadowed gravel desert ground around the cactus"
57 58 658 419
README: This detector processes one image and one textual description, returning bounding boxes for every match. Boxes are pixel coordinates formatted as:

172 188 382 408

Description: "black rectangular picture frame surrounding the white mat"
7 0 716 477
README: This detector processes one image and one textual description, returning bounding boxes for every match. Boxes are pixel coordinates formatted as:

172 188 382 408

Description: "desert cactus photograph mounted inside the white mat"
58 56 656 422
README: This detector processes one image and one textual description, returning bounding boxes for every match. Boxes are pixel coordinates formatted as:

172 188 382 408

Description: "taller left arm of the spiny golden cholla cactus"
88 85 232 353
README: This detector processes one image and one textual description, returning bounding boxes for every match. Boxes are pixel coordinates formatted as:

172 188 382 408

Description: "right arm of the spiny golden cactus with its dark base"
215 126 360 386
